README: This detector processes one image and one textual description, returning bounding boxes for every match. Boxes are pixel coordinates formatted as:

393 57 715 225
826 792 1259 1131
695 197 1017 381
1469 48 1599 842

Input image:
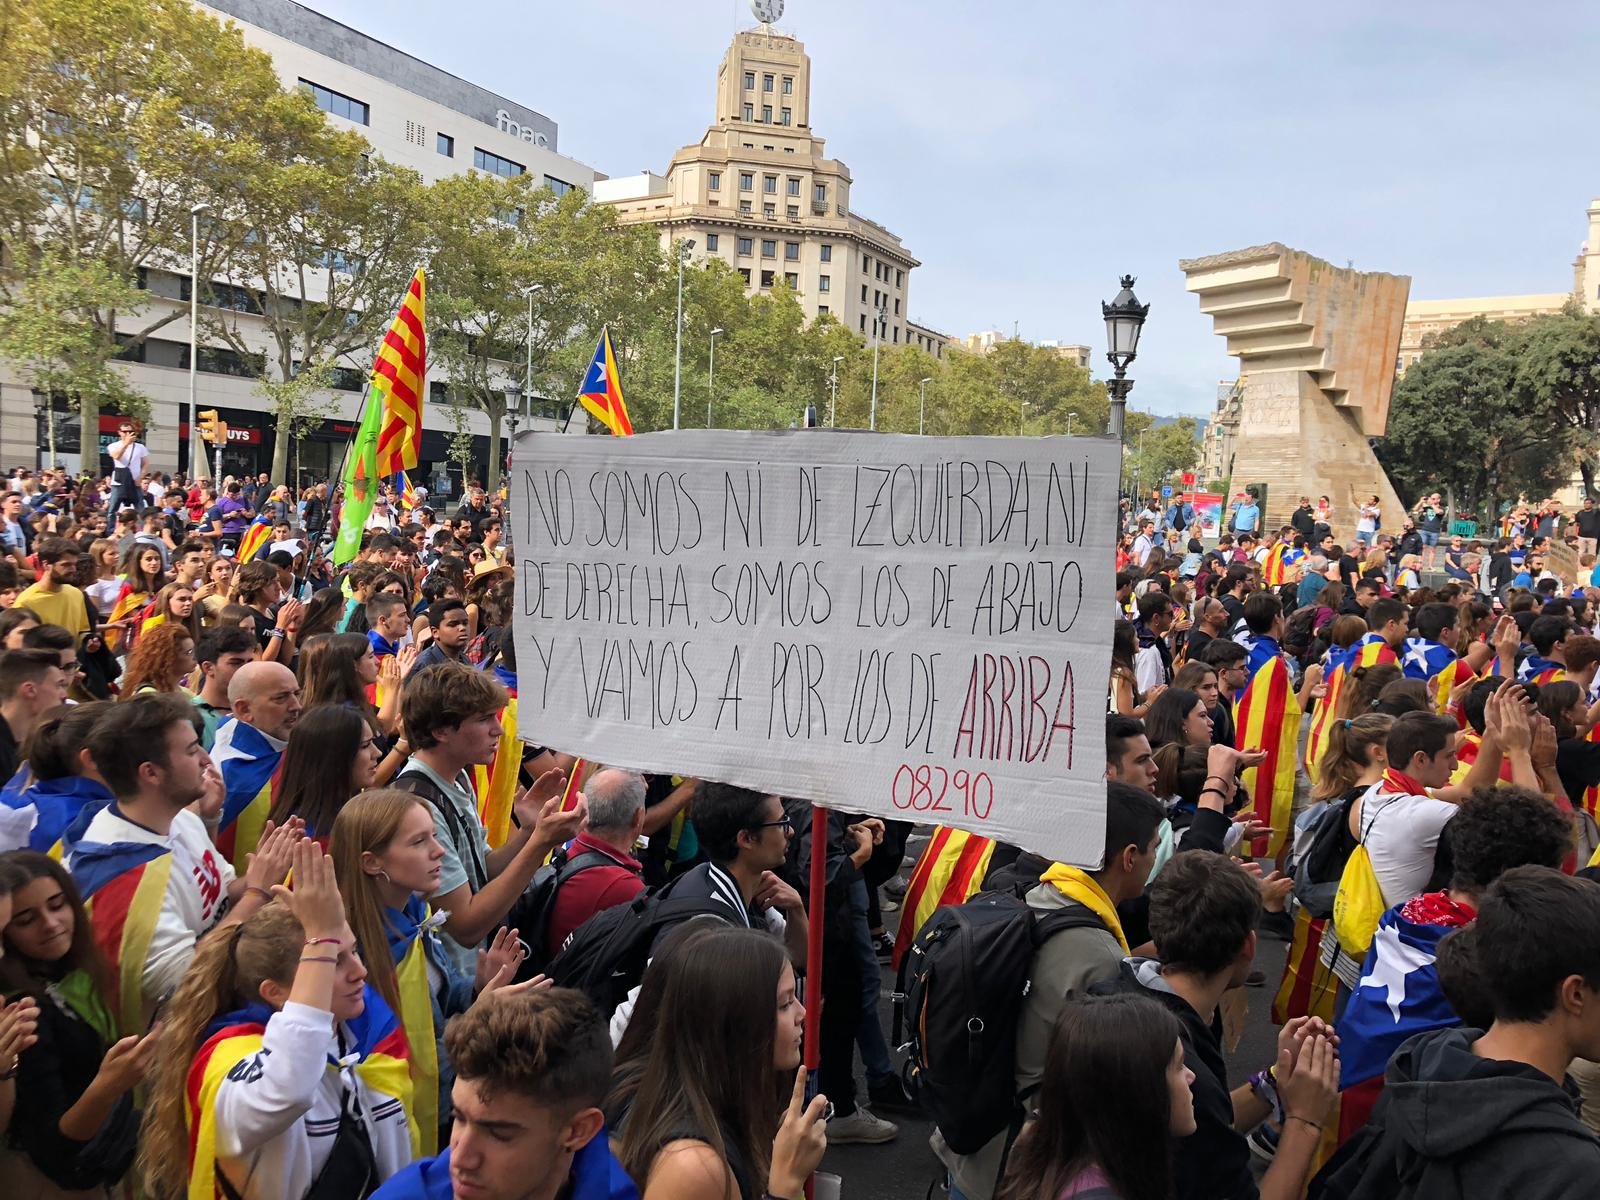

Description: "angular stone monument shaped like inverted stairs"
1178 242 1411 541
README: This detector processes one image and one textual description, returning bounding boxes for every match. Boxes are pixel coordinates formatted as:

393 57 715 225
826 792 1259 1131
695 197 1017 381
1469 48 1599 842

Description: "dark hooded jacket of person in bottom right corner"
1310 1029 1600 1200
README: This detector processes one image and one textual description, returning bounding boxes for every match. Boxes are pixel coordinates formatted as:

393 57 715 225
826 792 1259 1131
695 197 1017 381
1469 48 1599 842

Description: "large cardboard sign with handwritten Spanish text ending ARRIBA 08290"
510 430 1118 866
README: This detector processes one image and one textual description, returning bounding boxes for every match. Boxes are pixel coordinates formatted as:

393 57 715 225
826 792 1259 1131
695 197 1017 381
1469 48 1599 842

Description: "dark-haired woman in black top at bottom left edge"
0 851 160 1195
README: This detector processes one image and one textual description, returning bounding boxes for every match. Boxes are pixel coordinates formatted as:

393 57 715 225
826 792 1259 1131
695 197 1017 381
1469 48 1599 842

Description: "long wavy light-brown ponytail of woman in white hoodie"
139 901 306 1197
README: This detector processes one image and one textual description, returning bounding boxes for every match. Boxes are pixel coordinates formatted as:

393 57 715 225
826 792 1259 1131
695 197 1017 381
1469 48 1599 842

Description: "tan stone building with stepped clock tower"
594 27 949 347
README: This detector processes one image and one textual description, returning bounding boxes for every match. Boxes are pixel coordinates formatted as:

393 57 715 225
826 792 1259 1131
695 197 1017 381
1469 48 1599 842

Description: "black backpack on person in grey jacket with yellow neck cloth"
894 891 1104 1154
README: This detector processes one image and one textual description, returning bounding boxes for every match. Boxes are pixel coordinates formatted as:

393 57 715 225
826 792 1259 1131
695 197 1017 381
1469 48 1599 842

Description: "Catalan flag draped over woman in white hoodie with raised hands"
184 984 421 1200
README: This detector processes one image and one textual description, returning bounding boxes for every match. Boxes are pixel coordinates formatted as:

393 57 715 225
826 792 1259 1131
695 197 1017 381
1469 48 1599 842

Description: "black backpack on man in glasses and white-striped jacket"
544 875 731 1018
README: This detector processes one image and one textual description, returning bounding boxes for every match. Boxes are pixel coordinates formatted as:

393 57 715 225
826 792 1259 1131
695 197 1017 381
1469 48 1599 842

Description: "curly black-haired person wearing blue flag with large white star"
1336 787 1573 1142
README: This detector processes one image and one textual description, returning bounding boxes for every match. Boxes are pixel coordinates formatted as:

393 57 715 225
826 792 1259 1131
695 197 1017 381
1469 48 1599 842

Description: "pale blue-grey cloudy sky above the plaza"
309 0 1600 414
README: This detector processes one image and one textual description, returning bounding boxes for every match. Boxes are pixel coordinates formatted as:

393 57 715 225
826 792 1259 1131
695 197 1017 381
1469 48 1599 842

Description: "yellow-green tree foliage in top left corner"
0 0 331 453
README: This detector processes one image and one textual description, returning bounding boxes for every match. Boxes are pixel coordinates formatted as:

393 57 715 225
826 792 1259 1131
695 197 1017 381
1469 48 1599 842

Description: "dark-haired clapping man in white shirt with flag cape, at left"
62 694 302 1034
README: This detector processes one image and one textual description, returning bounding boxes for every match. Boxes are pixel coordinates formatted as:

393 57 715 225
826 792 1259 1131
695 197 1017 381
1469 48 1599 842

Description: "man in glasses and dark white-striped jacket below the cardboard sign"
656 781 806 970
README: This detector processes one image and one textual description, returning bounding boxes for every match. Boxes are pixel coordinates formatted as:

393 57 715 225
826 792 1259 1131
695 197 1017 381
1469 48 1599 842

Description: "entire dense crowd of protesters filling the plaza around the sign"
0 448 1600 1200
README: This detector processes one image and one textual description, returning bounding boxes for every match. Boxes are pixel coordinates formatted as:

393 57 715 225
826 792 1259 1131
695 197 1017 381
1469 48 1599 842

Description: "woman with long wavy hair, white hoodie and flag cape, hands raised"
144 838 416 1200
